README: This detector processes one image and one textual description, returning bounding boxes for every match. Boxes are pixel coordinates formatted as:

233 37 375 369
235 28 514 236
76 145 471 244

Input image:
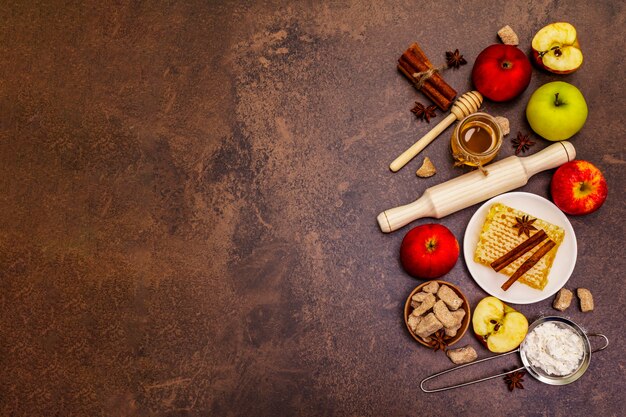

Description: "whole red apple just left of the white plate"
400 223 459 279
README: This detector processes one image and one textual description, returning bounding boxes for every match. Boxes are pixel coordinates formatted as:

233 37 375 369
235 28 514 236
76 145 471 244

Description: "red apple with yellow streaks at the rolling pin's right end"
550 160 608 215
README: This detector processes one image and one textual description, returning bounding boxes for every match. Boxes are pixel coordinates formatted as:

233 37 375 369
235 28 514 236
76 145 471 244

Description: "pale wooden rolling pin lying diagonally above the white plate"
377 141 576 233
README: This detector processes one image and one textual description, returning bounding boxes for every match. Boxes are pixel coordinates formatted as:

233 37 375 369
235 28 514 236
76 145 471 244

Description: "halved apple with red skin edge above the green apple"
531 22 583 74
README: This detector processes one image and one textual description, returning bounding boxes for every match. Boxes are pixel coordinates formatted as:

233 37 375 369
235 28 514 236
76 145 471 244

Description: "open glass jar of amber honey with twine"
450 113 502 168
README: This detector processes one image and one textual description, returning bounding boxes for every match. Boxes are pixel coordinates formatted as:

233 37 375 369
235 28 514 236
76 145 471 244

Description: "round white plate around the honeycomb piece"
463 192 578 304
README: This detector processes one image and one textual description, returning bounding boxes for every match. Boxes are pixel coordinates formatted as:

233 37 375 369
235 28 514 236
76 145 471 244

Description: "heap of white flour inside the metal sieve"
524 323 585 376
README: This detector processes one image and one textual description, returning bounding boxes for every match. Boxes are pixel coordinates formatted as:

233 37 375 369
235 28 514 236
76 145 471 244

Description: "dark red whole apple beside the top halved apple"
472 44 532 101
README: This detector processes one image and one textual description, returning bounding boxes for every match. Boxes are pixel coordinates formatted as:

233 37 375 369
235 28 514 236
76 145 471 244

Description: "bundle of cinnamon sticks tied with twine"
398 43 456 111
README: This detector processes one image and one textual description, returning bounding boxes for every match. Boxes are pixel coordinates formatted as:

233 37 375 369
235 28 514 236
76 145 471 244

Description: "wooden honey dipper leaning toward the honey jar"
389 91 483 172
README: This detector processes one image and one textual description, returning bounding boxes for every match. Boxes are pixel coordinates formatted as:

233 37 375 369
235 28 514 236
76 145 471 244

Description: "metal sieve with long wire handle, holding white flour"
420 316 609 392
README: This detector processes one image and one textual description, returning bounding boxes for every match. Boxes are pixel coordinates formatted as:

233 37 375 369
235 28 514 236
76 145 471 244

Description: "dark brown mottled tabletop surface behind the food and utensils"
0 0 626 416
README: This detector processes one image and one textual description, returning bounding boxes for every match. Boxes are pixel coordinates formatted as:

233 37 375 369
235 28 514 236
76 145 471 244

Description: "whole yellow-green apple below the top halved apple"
526 81 587 141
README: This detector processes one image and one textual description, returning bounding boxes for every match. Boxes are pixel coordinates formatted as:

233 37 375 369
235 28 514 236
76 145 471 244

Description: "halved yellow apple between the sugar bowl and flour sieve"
472 297 528 353
